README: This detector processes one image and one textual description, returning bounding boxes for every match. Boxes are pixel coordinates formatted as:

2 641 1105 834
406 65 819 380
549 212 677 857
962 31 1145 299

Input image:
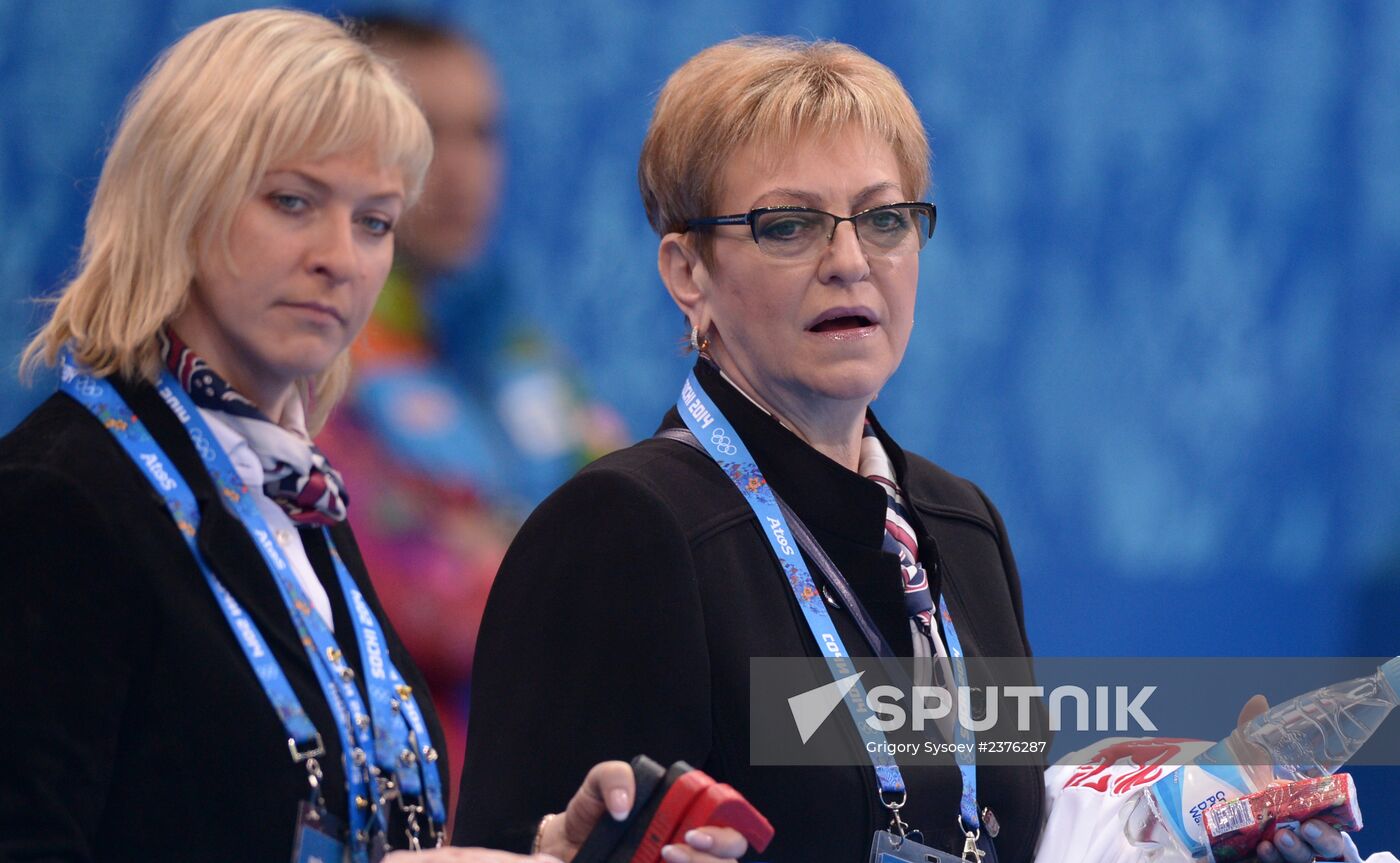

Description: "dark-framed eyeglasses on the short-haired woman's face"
686 200 938 261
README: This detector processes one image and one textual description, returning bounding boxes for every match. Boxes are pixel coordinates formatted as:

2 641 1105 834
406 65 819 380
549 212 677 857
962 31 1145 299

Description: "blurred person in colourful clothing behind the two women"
319 15 626 795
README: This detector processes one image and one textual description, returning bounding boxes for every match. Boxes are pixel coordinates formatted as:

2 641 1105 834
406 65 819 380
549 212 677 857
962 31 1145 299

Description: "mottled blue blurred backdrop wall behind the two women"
0 0 1400 849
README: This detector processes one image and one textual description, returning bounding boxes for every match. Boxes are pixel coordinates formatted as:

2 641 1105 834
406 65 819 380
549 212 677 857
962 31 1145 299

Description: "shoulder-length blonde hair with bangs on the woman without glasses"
21 10 433 433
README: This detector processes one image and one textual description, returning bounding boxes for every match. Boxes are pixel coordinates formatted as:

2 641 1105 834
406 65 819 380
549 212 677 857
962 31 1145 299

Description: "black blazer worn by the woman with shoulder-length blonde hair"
0 384 447 862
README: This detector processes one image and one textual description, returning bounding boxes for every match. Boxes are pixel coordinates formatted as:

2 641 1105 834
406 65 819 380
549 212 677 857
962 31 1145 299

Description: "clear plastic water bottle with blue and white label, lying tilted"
1123 657 1400 860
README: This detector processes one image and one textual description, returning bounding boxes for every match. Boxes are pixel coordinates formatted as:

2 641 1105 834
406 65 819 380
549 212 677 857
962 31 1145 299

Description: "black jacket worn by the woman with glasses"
456 363 1043 863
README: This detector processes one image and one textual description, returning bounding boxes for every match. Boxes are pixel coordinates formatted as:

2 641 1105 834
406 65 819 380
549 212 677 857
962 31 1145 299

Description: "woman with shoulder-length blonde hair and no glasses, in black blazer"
0 10 743 863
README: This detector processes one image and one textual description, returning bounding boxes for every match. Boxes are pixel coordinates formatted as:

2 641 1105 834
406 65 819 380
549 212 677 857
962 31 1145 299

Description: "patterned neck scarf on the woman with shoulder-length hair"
161 328 350 525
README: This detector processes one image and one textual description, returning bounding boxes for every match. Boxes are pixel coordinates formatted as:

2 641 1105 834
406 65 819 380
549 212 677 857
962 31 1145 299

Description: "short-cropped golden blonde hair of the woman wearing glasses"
637 36 928 263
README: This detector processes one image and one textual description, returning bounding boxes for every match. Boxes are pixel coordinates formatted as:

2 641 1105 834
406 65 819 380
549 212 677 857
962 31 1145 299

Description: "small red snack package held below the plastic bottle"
1204 773 1361 863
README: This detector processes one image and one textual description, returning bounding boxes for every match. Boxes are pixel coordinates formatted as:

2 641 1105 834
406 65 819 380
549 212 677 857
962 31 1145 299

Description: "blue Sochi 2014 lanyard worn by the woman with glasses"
676 373 979 835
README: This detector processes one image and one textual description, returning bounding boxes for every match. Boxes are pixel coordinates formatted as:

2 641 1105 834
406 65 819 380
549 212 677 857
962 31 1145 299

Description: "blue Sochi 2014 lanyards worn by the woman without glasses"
60 356 445 862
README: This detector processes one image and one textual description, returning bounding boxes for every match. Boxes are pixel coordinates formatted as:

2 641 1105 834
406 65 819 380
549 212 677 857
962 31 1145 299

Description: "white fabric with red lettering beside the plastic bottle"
1036 737 1400 863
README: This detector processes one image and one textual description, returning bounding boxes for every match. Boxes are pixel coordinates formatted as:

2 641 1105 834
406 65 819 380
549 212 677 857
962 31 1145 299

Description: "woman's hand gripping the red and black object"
539 761 749 863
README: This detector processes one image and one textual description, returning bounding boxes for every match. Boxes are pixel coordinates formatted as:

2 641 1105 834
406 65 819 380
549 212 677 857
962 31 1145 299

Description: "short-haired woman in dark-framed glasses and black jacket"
458 38 1043 862
